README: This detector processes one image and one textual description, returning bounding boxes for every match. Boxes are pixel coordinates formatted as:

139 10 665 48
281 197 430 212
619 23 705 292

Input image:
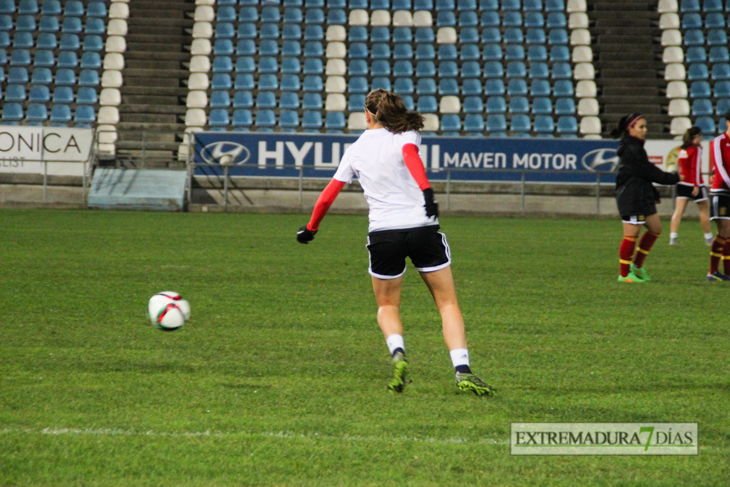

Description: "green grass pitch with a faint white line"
0 210 730 487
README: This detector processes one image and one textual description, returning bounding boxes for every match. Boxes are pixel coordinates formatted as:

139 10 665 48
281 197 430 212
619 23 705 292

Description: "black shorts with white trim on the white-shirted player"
367 225 451 279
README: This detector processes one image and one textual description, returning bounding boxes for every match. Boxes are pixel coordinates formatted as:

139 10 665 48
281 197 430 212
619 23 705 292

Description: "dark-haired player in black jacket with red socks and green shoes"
611 113 679 282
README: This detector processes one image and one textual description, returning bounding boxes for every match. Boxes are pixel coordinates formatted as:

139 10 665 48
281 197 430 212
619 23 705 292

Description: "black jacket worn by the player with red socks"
616 135 679 216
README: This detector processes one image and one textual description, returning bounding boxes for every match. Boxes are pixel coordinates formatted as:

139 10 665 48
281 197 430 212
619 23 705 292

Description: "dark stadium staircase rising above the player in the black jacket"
588 0 671 138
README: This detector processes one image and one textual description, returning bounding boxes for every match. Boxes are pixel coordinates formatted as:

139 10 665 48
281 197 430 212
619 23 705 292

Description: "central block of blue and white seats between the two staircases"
181 0 597 139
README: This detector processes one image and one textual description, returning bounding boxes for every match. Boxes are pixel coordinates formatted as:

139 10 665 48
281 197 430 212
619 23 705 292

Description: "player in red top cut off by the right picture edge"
707 111 730 281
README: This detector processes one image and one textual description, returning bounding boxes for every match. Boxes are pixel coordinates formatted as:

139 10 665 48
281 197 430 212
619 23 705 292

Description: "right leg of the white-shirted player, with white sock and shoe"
421 266 496 395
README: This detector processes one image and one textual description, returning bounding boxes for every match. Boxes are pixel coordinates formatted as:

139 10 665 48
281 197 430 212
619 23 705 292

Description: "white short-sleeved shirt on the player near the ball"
334 128 438 232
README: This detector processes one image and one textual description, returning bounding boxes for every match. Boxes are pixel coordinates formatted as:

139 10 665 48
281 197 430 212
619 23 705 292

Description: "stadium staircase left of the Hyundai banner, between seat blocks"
117 0 195 167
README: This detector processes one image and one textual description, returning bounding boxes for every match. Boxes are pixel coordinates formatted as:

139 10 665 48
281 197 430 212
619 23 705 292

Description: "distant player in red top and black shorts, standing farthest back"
669 127 712 245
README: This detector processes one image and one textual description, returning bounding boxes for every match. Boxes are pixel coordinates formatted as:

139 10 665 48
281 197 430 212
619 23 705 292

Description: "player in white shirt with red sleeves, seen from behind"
297 89 495 395
